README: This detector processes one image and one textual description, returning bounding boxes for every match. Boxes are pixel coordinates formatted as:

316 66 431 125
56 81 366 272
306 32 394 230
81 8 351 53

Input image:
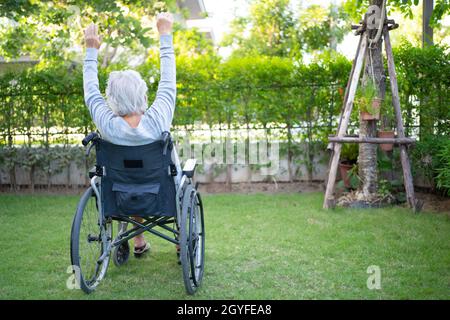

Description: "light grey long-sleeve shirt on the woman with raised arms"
83 35 176 146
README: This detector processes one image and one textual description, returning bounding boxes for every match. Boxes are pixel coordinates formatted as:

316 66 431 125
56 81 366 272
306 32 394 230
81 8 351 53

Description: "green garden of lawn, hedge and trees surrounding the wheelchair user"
0 0 450 299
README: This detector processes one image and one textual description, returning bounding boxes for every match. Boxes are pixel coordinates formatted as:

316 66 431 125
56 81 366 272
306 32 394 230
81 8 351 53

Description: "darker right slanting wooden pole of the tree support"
384 28 420 212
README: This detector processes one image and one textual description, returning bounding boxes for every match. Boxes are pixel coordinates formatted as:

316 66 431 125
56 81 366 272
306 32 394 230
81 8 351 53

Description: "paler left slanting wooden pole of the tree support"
323 34 367 209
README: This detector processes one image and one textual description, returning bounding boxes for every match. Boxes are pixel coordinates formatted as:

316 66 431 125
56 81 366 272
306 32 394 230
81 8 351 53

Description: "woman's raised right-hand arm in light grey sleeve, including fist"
147 13 176 131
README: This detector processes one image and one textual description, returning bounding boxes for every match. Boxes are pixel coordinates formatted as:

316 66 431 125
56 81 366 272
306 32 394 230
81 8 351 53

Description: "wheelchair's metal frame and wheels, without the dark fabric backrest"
71 133 205 294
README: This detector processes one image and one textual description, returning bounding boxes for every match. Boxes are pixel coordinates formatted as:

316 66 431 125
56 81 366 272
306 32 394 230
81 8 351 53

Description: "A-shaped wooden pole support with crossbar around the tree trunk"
323 13 420 212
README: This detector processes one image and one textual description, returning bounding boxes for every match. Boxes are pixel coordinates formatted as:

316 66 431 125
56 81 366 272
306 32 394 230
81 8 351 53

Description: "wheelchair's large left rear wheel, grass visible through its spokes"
70 187 112 293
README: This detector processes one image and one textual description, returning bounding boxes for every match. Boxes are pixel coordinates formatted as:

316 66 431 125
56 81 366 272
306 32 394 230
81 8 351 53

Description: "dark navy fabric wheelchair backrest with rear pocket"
96 138 176 217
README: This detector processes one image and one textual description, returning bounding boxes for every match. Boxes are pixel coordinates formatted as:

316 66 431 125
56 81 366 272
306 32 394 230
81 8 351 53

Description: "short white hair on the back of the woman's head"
106 70 147 116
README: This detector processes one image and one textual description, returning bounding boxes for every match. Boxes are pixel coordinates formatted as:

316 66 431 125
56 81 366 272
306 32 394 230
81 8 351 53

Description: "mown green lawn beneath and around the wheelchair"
0 193 450 299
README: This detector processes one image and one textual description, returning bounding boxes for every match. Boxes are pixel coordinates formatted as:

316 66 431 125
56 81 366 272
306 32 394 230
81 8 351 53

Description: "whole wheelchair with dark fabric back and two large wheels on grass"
70 132 205 294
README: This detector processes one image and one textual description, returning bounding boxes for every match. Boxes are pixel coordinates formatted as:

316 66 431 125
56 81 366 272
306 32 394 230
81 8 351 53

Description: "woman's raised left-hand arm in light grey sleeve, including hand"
83 24 114 133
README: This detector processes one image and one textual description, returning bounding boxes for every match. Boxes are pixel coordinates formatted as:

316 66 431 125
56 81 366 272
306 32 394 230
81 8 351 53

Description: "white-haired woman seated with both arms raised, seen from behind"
83 13 176 256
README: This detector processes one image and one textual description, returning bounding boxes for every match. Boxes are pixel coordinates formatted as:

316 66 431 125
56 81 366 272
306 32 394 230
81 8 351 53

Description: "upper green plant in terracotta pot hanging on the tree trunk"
355 80 382 121
